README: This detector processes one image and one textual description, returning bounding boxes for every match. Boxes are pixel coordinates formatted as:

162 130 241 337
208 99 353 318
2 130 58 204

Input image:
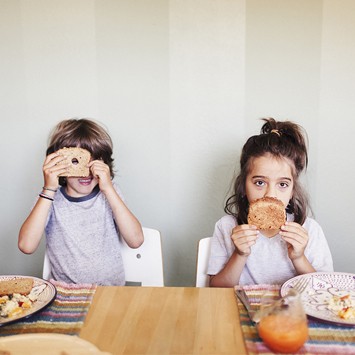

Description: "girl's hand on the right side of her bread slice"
280 222 308 260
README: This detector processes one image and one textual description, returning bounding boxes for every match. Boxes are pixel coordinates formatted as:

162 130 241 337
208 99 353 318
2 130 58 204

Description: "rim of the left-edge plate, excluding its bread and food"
0 275 57 327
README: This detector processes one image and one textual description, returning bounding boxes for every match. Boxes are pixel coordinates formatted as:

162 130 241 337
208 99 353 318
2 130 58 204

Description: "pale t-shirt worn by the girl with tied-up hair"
207 214 334 285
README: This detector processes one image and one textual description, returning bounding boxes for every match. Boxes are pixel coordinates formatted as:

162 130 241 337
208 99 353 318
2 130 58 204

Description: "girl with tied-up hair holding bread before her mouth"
208 118 333 287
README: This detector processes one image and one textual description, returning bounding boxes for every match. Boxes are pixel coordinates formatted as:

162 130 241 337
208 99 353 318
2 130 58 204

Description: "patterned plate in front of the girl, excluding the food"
280 272 355 326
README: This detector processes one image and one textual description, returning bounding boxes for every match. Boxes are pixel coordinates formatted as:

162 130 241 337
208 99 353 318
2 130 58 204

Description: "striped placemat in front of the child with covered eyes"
0 280 96 336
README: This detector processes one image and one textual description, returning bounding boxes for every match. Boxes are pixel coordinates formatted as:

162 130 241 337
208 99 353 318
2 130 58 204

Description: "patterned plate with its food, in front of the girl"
280 272 355 326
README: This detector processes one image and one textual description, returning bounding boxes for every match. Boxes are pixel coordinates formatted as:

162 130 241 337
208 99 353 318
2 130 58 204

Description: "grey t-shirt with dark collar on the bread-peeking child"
45 184 125 285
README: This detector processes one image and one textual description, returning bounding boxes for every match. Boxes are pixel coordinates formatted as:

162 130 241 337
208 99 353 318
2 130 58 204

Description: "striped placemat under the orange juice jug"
236 285 355 355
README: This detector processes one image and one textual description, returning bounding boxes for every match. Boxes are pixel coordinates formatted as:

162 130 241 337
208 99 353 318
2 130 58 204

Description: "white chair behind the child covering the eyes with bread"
43 228 164 286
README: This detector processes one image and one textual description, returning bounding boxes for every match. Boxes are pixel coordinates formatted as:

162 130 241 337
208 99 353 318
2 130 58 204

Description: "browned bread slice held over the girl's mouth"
248 197 286 230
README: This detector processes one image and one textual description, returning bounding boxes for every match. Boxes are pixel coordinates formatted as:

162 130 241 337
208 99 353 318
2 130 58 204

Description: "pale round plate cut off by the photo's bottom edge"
0 333 109 355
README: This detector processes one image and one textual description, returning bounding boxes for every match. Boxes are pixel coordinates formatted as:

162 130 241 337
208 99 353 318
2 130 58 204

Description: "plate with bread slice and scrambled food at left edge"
0 275 57 327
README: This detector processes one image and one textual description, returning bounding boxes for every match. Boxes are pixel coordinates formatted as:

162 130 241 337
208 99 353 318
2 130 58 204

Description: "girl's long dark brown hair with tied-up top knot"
224 118 308 225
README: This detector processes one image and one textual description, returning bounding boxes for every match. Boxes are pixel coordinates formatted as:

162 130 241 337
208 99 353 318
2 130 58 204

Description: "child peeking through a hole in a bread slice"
18 119 143 285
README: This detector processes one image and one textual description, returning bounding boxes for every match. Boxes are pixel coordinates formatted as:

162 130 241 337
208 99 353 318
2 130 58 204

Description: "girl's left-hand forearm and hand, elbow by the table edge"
210 224 258 287
